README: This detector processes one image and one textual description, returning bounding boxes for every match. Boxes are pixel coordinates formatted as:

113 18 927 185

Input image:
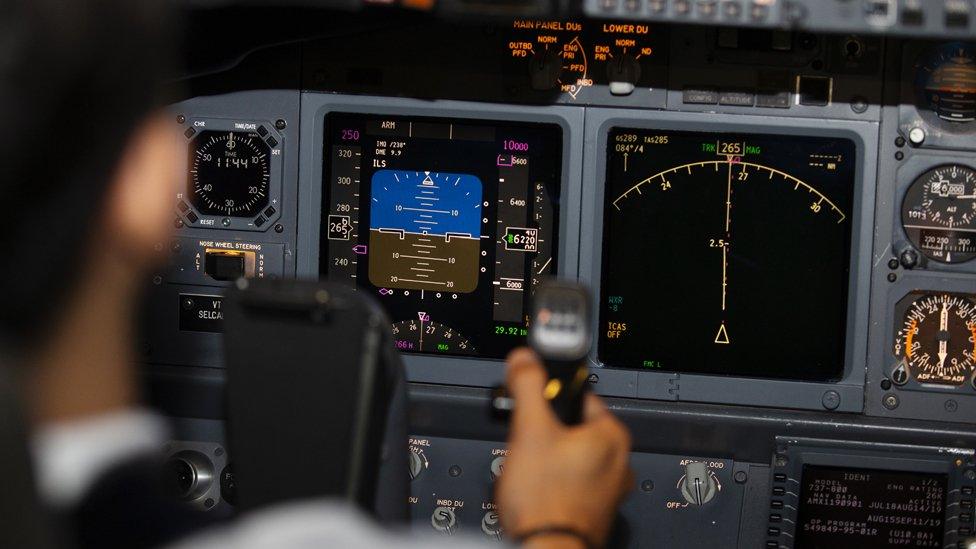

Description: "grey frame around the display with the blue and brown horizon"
298 93 583 387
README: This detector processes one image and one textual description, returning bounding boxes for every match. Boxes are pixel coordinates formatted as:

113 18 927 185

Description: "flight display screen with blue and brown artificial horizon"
319 113 562 358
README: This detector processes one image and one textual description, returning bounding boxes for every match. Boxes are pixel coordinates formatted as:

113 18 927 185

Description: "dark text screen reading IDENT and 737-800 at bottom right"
795 465 948 549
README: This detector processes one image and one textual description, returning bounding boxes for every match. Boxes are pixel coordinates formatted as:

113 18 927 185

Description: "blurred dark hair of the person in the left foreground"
0 0 176 346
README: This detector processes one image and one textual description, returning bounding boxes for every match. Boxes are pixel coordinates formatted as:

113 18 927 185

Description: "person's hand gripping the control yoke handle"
495 349 633 548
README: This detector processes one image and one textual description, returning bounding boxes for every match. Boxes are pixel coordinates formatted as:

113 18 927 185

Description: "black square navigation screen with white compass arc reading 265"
599 128 856 381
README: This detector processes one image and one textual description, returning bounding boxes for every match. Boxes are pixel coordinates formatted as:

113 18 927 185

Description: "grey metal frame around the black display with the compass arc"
580 108 878 412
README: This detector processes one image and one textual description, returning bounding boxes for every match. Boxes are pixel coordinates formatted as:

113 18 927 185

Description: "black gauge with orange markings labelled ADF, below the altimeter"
892 293 976 385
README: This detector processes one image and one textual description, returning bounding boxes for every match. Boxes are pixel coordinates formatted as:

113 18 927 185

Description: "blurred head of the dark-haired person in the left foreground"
0 0 177 351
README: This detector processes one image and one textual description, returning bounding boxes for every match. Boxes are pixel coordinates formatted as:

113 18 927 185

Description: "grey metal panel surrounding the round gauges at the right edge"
865 40 976 424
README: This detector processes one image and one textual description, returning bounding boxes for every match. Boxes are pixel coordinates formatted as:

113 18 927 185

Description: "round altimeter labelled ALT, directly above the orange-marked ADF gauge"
901 164 976 263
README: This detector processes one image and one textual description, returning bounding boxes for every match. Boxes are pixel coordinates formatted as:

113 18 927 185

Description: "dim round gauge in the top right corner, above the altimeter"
915 42 976 122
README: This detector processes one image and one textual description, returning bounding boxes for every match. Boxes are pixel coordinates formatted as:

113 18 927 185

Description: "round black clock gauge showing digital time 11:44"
187 131 271 217
